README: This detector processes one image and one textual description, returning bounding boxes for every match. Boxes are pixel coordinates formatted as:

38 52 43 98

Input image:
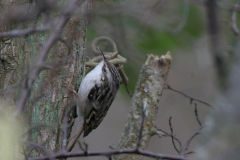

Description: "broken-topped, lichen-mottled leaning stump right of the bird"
114 53 171 160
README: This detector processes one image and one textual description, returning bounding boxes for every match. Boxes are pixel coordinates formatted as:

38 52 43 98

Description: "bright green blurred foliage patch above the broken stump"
136 5 203 54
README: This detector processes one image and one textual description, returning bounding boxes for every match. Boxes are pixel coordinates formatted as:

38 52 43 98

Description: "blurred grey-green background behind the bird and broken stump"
72 0 237 159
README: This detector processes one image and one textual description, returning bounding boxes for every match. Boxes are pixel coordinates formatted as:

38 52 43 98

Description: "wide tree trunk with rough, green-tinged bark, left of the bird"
0 0 92 157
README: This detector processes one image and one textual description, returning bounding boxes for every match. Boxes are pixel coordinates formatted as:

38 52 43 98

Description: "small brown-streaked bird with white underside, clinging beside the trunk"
67 47 121 150
